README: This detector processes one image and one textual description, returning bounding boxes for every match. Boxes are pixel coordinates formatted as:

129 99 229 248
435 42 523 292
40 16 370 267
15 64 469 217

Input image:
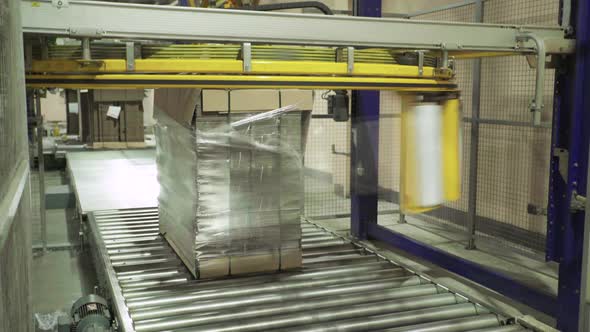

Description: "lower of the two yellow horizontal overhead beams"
26 74 457 91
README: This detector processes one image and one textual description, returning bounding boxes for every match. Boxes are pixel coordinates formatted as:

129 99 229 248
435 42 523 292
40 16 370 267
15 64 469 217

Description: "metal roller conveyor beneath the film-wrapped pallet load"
88 208 526 332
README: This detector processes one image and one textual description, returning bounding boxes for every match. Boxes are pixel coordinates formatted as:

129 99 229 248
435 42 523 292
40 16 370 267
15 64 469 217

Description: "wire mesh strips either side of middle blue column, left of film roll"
304 90 401 219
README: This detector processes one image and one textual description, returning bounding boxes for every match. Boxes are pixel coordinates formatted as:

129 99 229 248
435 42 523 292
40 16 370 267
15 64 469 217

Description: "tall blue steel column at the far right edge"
547 0 590 332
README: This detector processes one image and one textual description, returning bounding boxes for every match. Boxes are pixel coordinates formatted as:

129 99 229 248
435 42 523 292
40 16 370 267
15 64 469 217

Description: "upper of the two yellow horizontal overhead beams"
29 59 451 79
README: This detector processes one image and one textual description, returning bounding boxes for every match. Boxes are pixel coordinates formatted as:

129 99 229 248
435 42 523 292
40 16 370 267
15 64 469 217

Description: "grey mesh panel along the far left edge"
0 0 33 332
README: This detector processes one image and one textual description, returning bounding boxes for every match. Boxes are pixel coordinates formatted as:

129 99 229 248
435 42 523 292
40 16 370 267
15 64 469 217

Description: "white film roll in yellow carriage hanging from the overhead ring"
401 98 462 214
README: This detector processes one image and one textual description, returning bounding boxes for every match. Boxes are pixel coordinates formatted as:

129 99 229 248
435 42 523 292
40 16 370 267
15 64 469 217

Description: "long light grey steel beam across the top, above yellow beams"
20 0 571 53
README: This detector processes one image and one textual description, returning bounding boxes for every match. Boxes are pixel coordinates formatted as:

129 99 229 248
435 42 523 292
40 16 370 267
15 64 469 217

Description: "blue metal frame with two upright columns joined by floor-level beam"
351 0 590 332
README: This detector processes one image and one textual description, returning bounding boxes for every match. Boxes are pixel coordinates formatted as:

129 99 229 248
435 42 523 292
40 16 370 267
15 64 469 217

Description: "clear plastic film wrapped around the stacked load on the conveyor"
156 106 309 278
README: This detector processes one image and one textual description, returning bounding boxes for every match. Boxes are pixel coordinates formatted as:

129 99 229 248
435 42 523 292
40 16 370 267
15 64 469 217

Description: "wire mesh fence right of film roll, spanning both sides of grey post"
380 0 559 252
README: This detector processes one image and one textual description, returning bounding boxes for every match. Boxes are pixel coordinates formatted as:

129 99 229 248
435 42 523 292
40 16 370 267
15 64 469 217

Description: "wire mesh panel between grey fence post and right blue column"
477 0 559 251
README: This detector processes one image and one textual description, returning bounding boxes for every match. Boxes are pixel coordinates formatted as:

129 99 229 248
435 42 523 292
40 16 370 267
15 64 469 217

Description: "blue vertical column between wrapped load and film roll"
350 0 386 240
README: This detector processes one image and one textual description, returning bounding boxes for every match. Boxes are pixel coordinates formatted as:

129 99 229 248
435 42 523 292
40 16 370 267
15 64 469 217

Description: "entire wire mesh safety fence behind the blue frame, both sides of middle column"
305 0 559 252
